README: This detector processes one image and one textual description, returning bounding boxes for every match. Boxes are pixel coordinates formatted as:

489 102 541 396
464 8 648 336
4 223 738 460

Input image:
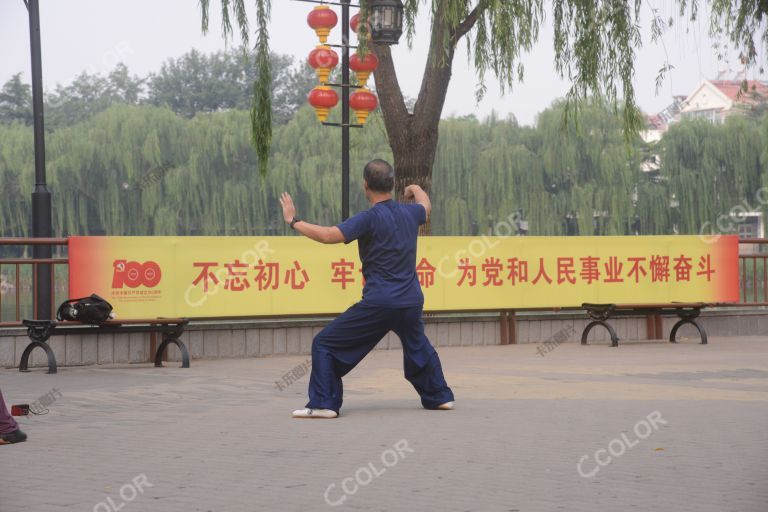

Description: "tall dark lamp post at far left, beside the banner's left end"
24 0 53 320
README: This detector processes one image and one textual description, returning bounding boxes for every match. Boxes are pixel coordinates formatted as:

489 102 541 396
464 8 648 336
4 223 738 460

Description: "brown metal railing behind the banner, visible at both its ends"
0 238 768 327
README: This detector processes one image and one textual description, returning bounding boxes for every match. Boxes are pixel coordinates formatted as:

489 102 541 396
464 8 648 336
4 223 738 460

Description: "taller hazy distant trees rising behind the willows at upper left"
0 49 315 131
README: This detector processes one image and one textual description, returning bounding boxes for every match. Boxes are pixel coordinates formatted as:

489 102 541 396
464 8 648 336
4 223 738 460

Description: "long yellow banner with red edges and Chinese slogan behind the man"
69 236 738 318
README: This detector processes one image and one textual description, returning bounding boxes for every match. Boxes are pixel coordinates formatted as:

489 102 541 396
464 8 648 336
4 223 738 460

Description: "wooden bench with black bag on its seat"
19 318 189 373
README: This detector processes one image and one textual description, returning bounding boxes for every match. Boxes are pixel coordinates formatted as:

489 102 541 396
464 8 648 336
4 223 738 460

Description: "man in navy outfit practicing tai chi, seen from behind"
280 160 453 418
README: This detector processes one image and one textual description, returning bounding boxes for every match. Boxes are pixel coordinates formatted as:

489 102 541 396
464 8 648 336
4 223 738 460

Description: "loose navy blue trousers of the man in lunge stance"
307 302 453 412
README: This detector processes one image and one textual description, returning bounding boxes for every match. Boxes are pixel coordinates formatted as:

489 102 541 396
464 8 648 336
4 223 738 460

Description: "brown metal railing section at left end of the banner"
0 238 69 327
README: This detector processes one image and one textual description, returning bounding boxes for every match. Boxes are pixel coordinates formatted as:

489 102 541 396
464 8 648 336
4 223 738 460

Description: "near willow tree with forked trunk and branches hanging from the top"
200 0 768 204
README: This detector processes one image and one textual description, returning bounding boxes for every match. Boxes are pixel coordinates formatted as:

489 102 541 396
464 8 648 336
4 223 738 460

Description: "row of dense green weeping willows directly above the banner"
0 102 768 236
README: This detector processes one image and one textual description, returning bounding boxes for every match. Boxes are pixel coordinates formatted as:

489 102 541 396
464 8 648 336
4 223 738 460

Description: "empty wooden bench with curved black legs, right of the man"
581 302 711 347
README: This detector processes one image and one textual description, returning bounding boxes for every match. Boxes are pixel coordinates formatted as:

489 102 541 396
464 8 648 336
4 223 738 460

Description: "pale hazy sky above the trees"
0 0 765 124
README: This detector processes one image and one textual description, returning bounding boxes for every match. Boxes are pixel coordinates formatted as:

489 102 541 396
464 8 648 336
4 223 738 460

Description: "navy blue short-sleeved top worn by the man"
338 199 427 308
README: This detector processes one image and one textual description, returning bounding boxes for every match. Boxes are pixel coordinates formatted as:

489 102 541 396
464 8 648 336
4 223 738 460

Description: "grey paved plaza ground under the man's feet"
0 337 768 512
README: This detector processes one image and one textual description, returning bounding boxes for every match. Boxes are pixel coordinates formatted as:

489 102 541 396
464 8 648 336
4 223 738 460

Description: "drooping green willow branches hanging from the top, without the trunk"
207 0 768 164
